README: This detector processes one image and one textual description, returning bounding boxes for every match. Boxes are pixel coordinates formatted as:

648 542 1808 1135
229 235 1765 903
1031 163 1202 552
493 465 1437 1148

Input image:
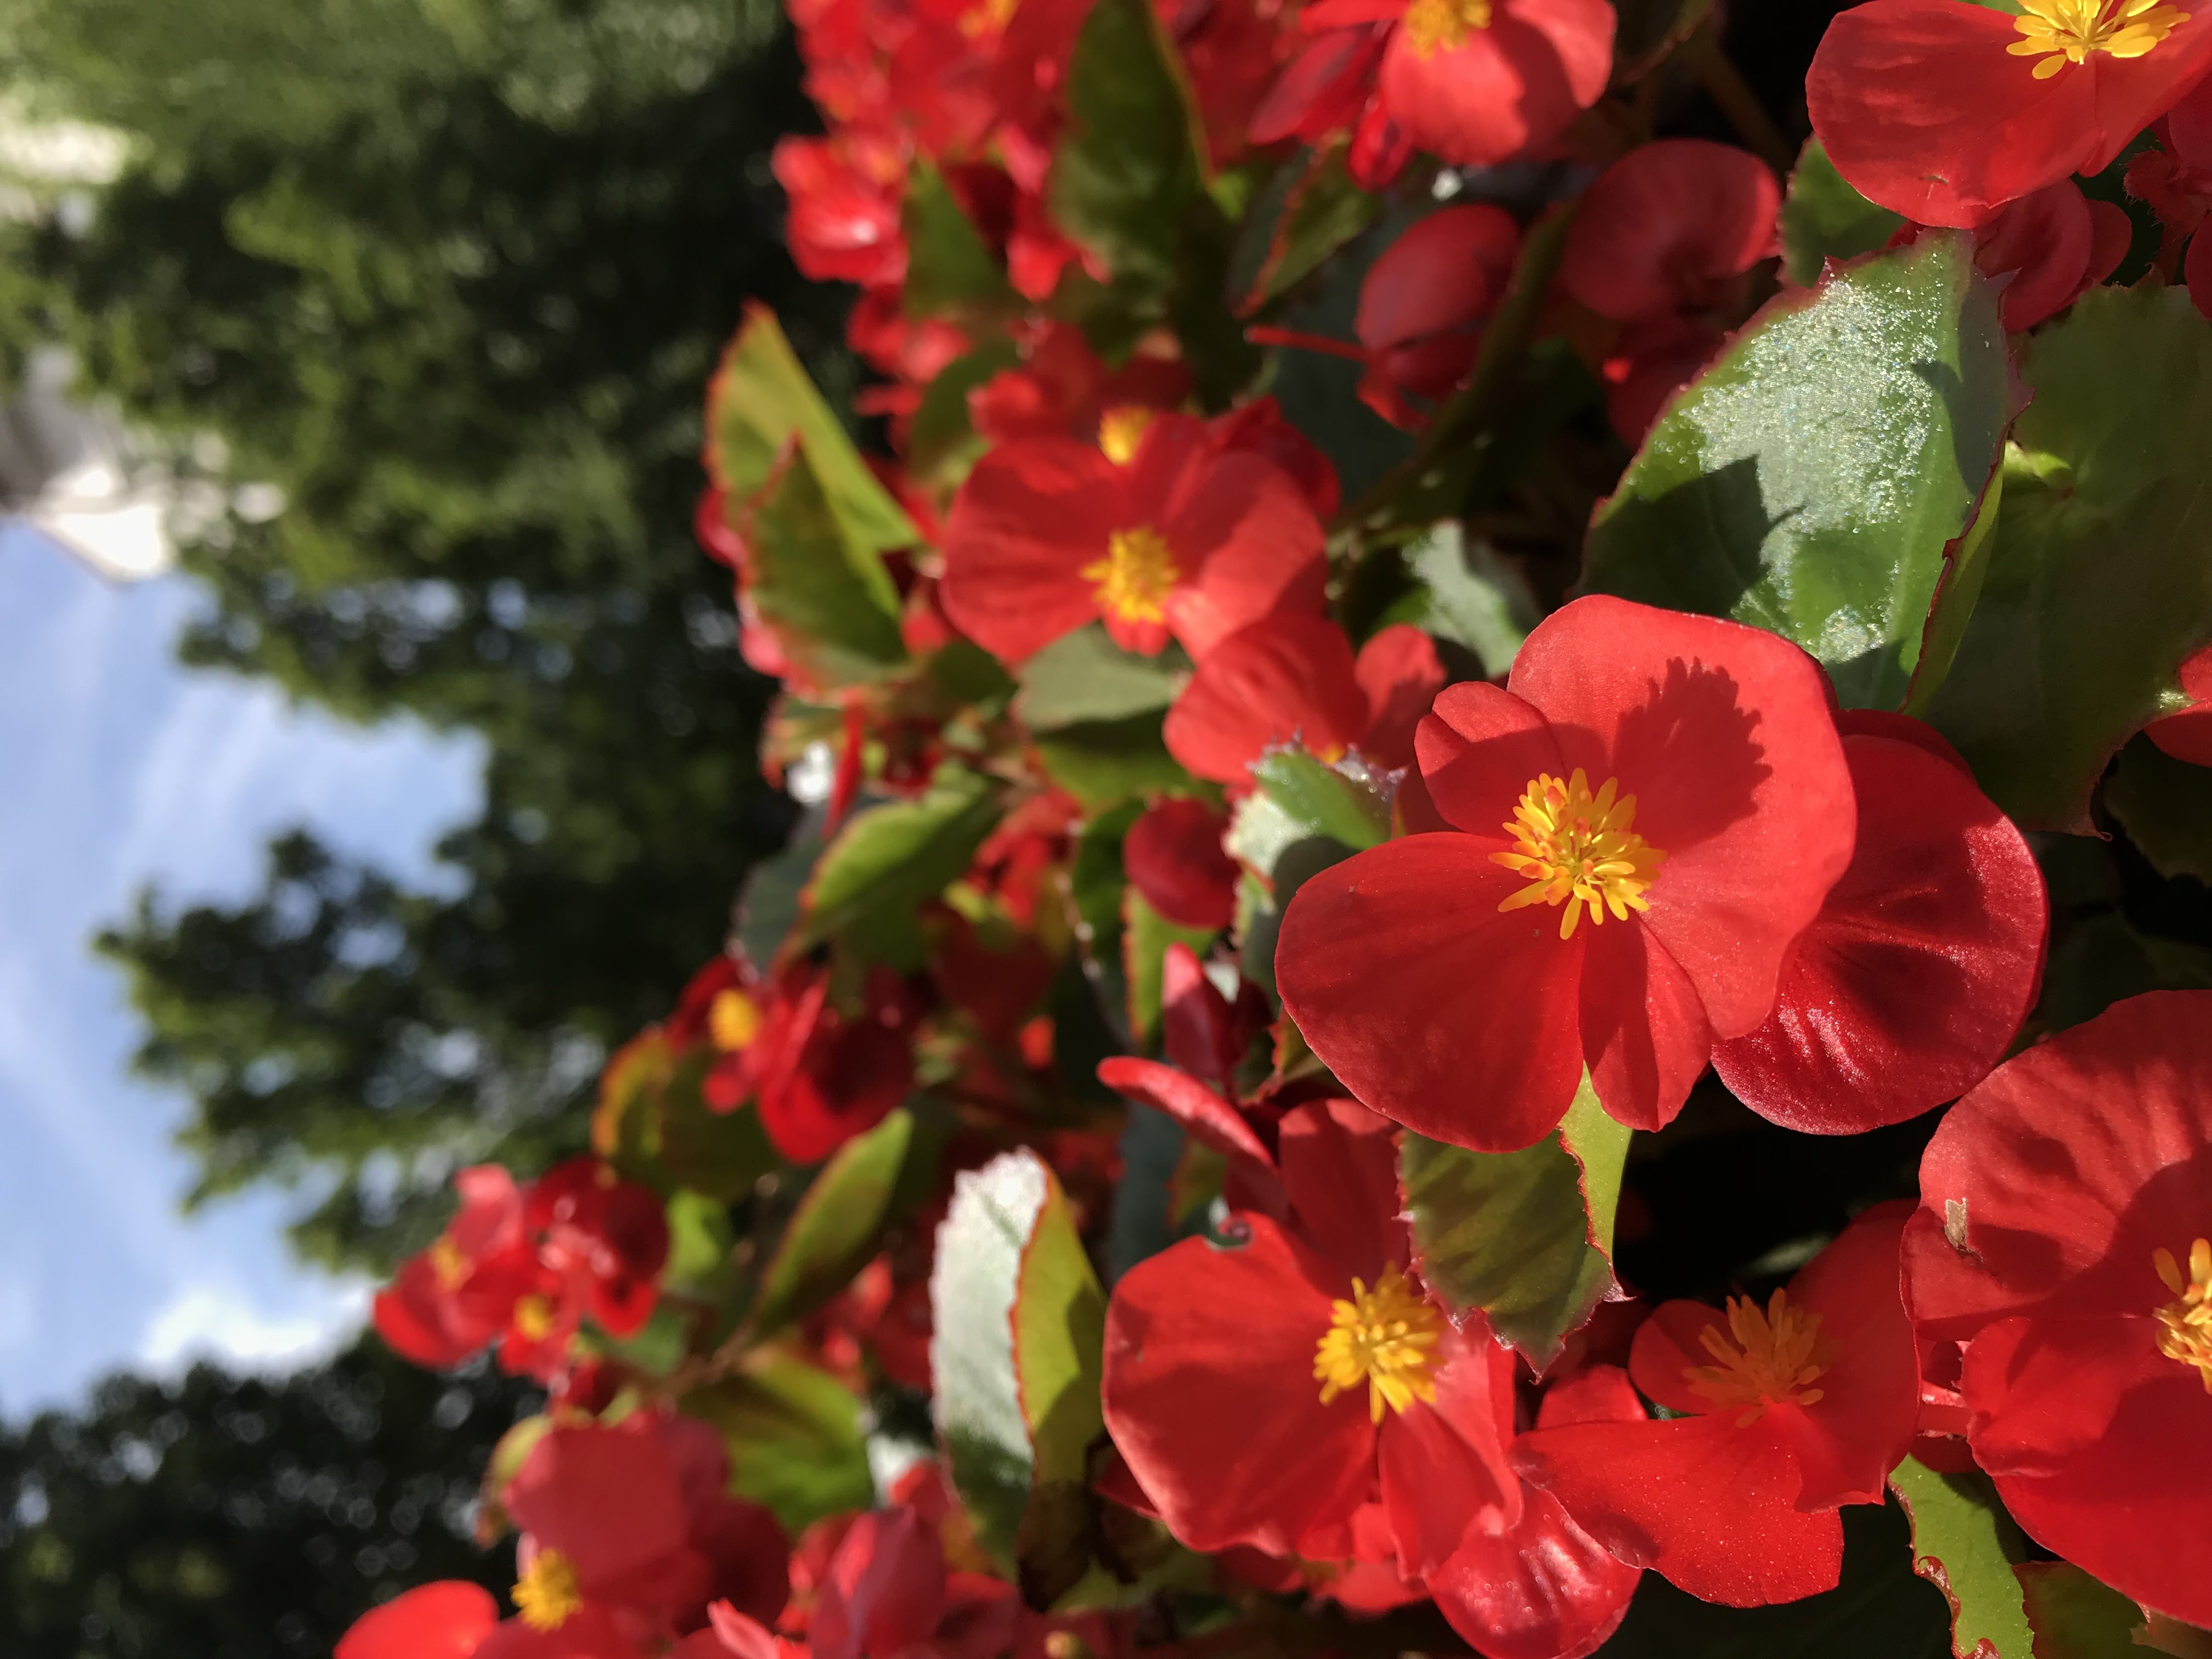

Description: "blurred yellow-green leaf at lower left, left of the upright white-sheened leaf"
679 1352 876 1537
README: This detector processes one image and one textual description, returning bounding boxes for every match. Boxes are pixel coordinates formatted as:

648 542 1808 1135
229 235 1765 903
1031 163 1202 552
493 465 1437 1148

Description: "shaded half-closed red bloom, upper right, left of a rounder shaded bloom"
1352 201 1520 425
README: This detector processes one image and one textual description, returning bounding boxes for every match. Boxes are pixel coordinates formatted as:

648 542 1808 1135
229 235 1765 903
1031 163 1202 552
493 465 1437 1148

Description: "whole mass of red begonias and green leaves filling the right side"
338 0 2212 1659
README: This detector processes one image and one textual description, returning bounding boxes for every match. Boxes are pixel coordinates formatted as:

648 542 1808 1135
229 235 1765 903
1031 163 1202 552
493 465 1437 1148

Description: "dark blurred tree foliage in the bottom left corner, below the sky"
0 1338 535 1659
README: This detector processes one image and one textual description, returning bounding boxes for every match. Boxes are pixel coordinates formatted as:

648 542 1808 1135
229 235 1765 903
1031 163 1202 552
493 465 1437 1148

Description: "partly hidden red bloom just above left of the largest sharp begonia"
1166 617 1444 783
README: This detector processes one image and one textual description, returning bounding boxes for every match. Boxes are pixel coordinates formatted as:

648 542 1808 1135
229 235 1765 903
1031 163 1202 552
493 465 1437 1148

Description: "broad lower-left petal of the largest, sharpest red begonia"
1274 834 1590 1153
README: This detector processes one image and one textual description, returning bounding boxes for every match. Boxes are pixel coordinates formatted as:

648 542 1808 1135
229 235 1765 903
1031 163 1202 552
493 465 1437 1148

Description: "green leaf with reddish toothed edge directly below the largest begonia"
1398 1077 1628 1372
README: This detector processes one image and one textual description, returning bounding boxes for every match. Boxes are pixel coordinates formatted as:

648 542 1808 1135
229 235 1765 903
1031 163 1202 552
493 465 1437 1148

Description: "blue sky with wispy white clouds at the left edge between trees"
0 527 482 1418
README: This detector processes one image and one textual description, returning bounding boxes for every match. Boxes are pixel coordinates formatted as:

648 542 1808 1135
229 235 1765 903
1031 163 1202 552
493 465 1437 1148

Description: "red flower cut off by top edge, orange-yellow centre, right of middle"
1301 0 1612 166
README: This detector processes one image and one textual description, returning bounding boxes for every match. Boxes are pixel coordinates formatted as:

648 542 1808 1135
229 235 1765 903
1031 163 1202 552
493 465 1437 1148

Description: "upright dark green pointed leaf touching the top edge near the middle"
1046 0 1219 290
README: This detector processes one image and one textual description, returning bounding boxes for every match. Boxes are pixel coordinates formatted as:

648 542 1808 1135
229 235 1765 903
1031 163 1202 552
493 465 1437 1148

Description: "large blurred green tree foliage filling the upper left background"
0 0 849 1265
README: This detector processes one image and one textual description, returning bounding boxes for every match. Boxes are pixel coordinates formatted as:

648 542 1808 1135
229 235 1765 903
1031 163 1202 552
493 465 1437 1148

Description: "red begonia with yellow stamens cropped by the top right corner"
1805 0 2212 228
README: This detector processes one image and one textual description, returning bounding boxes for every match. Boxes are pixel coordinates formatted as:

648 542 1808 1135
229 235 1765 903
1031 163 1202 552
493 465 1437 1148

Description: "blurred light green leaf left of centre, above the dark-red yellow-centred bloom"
803 765 1000 967
